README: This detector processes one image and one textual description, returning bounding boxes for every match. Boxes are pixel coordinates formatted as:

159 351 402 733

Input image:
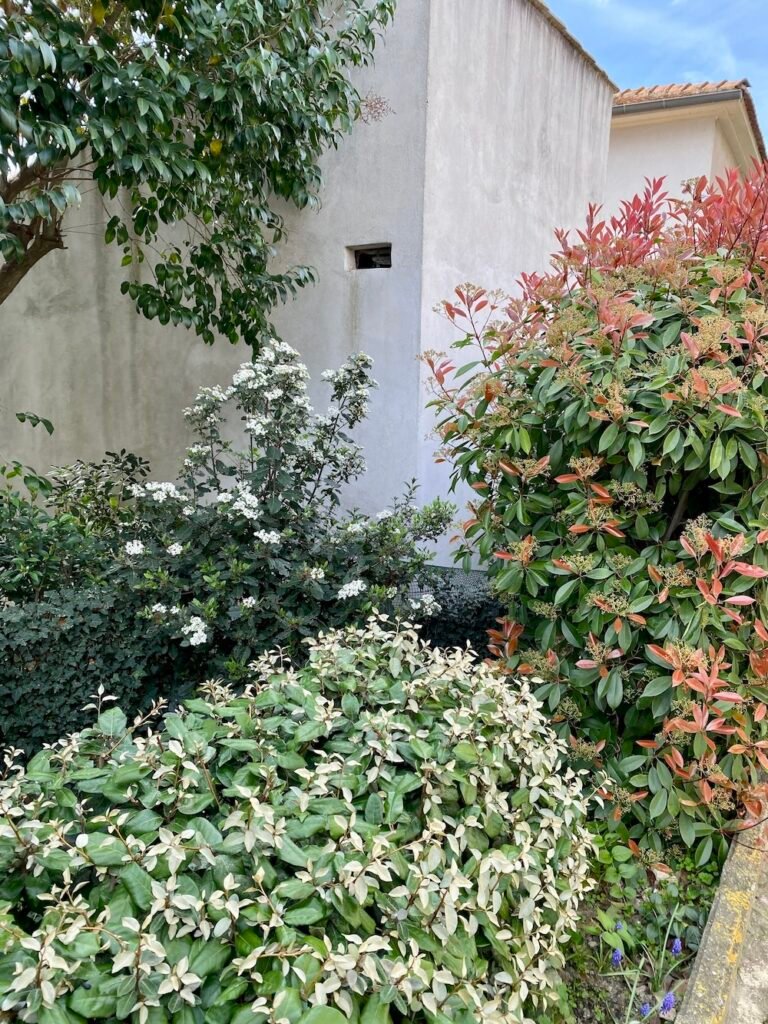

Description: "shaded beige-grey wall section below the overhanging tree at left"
0 179 246 478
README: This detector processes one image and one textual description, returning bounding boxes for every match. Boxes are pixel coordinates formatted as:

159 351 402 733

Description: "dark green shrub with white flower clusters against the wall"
115 341 454 679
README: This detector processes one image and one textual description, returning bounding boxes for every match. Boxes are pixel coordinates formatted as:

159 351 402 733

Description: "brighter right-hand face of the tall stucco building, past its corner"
419 0 613 557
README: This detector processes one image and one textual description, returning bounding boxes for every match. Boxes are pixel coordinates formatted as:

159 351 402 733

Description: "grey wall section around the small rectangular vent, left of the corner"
268 0 430 512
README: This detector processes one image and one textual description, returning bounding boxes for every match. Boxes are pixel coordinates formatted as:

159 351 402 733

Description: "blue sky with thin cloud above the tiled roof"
546 0 768 128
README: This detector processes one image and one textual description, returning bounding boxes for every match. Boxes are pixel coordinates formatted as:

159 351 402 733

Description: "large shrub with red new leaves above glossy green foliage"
427 168 768 864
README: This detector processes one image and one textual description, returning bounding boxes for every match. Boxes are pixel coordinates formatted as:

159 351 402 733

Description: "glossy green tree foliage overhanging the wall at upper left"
0 0 395 345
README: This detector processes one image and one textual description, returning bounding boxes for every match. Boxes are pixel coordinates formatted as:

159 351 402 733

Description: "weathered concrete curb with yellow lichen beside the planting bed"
675 821 768 1024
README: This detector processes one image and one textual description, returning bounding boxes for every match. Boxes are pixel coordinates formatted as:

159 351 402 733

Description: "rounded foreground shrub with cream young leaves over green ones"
0 617 591 1024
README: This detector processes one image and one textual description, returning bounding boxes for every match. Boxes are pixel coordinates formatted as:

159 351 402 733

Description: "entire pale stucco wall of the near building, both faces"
0 0 612 544
